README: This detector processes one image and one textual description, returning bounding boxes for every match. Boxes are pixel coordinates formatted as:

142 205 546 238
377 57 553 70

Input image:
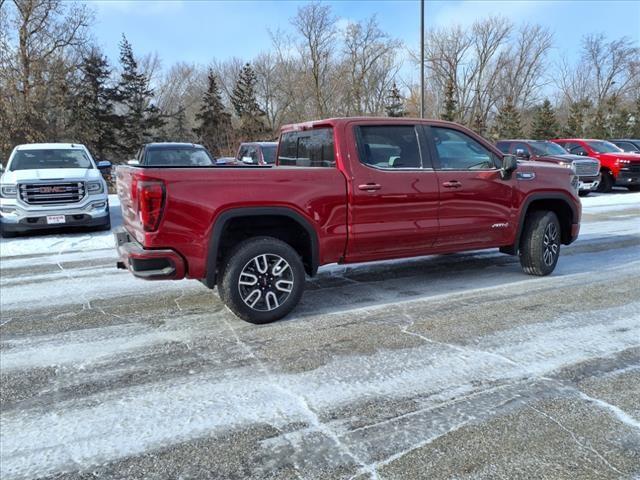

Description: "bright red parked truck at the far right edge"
552 138 640 192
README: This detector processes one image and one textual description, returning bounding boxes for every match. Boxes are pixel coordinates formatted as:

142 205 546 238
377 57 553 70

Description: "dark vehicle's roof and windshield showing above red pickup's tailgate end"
127 142 216 167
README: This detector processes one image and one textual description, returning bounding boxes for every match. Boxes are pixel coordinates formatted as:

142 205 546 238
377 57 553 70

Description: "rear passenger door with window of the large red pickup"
346 121 438 261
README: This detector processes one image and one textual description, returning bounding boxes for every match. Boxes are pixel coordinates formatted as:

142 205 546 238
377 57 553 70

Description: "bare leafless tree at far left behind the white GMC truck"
0 0 91 144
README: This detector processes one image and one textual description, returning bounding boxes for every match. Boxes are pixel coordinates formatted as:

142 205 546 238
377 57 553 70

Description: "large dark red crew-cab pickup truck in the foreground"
116 118 581 323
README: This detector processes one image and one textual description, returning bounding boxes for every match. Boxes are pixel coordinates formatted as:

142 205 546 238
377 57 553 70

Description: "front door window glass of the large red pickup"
431 127 498 170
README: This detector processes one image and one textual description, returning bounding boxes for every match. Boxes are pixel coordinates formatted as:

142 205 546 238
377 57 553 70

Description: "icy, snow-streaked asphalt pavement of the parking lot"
0 190 640 480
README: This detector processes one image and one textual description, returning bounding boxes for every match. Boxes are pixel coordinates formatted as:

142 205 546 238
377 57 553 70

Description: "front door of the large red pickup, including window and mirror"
427 126 516 248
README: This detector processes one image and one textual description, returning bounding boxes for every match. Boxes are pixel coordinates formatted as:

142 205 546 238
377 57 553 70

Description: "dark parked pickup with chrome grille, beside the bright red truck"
496 140 600 197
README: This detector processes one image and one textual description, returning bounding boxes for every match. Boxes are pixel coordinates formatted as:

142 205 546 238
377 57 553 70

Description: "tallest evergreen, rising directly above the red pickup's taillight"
117 35 165 155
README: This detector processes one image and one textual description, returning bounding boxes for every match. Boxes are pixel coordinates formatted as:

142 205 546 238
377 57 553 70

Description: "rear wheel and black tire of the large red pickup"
218 237 305 324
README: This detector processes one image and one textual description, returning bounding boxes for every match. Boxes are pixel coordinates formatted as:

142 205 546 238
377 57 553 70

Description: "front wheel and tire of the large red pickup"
519 210 561 276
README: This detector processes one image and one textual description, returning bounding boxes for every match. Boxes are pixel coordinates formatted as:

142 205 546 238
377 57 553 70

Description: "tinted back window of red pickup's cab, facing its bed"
278 128 336 167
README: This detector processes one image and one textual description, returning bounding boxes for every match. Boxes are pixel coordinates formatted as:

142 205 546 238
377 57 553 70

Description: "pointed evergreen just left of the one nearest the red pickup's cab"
193 70 231 157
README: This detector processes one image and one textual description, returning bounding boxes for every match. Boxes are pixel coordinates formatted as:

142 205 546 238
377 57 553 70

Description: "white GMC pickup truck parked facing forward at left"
0 143 111 237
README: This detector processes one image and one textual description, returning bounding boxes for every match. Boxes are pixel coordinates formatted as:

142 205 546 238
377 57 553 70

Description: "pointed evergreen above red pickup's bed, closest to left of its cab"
231 63 267 141
